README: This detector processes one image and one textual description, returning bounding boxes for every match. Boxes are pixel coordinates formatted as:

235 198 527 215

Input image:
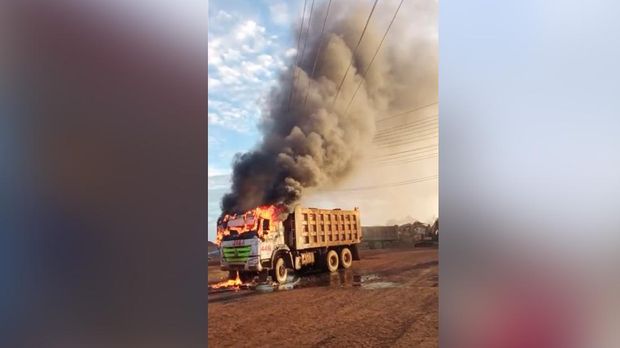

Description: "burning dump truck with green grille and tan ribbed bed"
217 205 362 283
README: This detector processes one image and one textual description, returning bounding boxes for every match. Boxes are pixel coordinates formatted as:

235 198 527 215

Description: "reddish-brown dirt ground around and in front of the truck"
208 248 439 347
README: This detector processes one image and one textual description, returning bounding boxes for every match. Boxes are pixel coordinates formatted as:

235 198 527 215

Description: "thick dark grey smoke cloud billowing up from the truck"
222 1 436 213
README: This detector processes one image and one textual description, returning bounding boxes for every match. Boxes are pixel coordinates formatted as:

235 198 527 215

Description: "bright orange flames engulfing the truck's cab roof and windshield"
215 204 288 245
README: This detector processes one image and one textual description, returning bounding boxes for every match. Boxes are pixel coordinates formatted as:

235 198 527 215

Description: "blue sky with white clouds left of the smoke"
208 0 303 240
